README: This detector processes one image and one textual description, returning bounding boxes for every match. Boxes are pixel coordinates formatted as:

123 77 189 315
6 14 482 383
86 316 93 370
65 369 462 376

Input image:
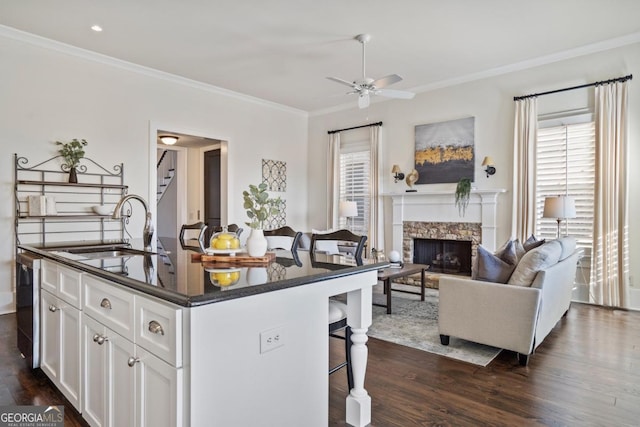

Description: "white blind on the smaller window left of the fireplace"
339 142 371 235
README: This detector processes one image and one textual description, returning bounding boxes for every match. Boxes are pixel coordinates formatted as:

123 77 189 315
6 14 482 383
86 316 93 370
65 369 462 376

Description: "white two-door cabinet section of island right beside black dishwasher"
40 261 82 411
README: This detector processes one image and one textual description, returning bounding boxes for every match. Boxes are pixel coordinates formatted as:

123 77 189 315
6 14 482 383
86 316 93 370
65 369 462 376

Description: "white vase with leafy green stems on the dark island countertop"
242 182 282 257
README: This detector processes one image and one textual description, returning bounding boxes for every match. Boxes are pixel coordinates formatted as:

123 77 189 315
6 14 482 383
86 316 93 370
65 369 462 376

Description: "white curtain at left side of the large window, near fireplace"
511 97 538 242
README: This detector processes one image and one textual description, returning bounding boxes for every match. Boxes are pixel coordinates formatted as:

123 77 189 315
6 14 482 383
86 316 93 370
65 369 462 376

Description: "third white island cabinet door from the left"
82 316 108 426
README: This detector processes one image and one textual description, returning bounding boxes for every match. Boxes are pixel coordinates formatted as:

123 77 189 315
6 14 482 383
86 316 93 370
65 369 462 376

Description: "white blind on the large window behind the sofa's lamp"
536 121 595 255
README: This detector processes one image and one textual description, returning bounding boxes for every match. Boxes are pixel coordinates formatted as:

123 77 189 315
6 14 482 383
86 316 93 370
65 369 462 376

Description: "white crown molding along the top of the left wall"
0 25 308 117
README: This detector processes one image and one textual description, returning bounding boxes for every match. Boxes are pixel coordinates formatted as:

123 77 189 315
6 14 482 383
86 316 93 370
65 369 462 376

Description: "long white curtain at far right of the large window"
590 82 629 307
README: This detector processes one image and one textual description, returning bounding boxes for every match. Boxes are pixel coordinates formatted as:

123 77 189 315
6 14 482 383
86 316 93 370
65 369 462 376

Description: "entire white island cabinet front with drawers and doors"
41 260 188 427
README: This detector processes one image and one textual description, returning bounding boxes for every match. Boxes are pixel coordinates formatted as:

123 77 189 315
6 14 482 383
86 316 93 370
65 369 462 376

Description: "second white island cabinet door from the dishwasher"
58 300 82 411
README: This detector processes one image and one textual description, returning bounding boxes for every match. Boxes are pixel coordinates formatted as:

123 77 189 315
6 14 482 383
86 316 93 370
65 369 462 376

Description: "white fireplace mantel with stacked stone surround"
387 189 506 286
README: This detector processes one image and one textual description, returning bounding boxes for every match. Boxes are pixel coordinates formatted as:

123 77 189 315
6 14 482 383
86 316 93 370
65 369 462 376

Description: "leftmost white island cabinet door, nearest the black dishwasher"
40 289 60 383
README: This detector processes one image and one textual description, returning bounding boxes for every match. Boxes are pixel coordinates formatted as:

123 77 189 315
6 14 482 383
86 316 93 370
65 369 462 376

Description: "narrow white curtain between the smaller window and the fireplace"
367 126 384 249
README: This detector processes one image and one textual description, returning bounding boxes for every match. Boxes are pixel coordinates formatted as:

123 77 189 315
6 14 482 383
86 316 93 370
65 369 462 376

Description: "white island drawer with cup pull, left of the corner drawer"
84 275 135 341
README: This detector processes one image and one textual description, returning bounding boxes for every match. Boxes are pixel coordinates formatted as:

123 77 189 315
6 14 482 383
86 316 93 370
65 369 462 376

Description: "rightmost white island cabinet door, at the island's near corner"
136 347 184 427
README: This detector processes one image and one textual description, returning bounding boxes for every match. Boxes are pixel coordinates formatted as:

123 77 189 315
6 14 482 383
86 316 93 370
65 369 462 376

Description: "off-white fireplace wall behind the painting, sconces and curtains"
309 44 640 308
